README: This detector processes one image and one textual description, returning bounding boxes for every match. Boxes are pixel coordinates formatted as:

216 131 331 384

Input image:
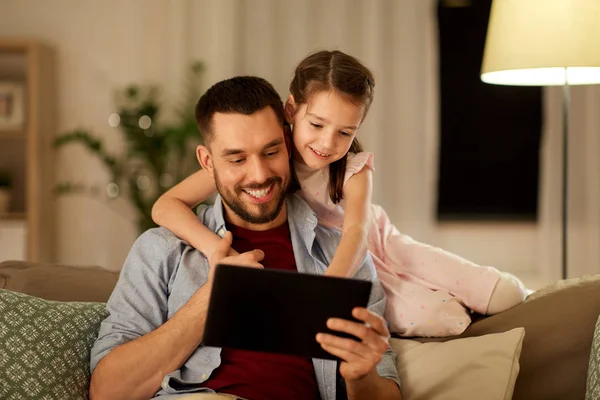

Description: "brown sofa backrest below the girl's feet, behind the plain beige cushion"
417 274 600 400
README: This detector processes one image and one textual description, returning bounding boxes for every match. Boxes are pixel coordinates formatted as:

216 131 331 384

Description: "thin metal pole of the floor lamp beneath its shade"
562 73 571 279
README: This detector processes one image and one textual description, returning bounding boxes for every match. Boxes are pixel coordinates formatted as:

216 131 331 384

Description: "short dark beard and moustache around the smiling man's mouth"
215 170 289 224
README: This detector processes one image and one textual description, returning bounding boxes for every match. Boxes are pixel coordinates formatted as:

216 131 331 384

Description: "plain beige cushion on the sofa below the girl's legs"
390 328 525 400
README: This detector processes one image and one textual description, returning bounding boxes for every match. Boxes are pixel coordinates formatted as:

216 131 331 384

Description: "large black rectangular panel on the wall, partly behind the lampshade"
437 0 542 221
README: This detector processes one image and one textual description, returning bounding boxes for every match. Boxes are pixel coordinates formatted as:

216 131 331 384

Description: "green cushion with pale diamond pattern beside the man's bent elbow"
0 289 108 400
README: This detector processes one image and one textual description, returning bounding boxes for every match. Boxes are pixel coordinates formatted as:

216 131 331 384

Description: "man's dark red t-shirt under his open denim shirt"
204 223 319 400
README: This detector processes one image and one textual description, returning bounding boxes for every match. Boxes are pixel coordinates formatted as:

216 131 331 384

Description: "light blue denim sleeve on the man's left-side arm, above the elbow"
90 228 181 372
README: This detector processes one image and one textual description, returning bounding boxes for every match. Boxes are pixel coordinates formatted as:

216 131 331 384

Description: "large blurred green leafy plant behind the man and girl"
54 62 209 233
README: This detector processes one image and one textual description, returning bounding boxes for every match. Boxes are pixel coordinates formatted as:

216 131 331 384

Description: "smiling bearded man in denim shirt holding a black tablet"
90 77 400 400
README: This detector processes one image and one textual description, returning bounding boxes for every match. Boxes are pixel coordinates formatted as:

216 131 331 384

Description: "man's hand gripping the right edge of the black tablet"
317 307 390 382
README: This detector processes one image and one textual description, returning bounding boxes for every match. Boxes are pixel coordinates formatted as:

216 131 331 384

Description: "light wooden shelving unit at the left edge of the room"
0 37 57 262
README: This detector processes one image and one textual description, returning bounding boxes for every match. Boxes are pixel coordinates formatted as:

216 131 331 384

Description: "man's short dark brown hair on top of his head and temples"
196 76 285 145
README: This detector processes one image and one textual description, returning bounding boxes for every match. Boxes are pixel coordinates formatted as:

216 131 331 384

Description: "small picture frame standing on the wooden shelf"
0 81 25 131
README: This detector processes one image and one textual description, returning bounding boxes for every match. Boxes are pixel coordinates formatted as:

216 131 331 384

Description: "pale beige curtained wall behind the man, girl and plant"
0 0 600 285
